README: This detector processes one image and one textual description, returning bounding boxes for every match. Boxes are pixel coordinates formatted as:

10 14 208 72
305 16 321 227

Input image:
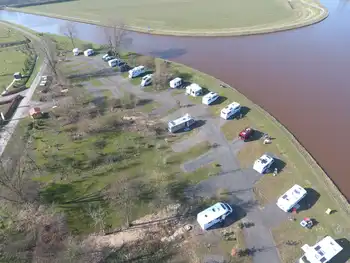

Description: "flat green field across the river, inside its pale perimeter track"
21 0 298 31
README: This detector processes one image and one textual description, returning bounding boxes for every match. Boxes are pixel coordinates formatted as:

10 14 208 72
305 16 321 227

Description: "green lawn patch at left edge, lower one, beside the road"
0 47 26 92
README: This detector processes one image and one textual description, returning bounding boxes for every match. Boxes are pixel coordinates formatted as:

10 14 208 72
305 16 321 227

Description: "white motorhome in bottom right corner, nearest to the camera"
299 236 343 263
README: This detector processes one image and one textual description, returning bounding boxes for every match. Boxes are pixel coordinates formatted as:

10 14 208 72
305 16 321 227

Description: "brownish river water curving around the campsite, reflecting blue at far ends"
0 0 350 200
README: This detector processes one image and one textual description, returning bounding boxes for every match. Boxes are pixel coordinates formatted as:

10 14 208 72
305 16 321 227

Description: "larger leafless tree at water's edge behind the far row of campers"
104 20 128 57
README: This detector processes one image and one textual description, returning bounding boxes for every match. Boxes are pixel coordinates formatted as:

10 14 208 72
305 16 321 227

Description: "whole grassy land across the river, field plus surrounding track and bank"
7 0 328 36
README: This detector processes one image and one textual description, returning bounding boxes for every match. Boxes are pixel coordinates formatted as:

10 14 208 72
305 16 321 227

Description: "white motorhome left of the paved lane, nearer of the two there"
197 202 232 230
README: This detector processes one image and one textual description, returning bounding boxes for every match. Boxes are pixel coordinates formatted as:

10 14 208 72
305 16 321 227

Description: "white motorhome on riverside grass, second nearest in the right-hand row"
276 184 307 212
